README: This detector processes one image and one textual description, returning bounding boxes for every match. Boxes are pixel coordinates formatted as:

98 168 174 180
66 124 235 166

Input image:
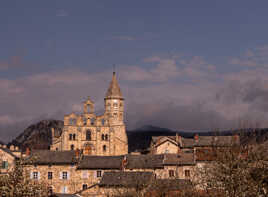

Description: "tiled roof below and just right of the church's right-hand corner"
126 155 164 169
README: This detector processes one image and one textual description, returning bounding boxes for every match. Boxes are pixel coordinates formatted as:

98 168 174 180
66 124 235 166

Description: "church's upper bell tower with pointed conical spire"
104 72 124 125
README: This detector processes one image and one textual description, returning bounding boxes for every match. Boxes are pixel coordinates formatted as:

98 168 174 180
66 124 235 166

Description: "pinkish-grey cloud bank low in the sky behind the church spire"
0 48 268 140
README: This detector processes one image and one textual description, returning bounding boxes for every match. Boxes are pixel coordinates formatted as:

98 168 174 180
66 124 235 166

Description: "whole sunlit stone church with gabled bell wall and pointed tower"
50 72 128 156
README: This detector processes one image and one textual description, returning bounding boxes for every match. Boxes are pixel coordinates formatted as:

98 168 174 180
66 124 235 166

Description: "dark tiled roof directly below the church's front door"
78 156 123 169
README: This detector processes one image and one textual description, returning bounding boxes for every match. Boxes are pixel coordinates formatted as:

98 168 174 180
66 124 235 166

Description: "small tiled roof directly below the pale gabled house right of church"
164 153 195 165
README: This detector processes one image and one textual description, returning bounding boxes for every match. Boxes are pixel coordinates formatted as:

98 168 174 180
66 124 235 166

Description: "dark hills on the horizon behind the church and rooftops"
9 120 268 152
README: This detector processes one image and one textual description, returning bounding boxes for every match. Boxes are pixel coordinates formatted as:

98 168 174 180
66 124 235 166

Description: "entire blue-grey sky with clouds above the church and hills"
0 0 268 142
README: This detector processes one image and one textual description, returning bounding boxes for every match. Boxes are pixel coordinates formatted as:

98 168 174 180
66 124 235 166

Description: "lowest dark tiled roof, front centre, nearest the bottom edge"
99 172 154 187
